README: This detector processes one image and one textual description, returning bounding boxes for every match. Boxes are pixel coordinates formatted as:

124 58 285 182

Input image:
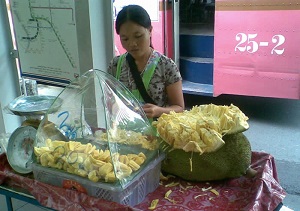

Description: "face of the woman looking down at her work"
119 21 151 59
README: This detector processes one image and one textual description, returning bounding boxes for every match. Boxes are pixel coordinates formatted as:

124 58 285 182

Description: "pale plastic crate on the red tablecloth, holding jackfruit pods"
32 154 165 206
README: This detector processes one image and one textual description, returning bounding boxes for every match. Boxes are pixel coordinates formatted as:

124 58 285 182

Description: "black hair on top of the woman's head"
116 5 152 34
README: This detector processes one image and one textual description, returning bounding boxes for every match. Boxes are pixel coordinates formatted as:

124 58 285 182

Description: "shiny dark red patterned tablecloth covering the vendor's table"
0 152 286 211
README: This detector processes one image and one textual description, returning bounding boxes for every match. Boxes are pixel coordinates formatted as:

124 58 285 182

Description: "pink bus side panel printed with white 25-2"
214 0 300 99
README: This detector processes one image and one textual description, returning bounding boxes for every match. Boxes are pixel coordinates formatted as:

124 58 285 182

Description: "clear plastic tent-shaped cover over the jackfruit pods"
34 70 159 187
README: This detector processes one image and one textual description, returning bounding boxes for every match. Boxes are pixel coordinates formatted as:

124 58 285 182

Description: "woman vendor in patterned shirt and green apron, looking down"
108 5 184 118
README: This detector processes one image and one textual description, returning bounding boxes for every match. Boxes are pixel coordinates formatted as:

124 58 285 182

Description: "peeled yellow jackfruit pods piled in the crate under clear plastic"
34 139 146 182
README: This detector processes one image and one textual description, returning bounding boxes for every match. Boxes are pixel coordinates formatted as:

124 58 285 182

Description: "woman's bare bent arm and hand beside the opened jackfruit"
143 81 184 118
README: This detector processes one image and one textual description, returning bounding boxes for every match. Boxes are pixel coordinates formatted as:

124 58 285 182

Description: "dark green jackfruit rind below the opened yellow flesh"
161 133 251 181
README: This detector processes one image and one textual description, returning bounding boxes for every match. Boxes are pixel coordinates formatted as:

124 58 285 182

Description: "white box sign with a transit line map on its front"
11 0 92 86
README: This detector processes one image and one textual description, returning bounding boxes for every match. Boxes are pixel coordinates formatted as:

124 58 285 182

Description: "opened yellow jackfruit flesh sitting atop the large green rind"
153 104 249 154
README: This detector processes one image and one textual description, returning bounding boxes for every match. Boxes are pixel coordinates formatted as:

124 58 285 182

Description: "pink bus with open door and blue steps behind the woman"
115 0 300 99
